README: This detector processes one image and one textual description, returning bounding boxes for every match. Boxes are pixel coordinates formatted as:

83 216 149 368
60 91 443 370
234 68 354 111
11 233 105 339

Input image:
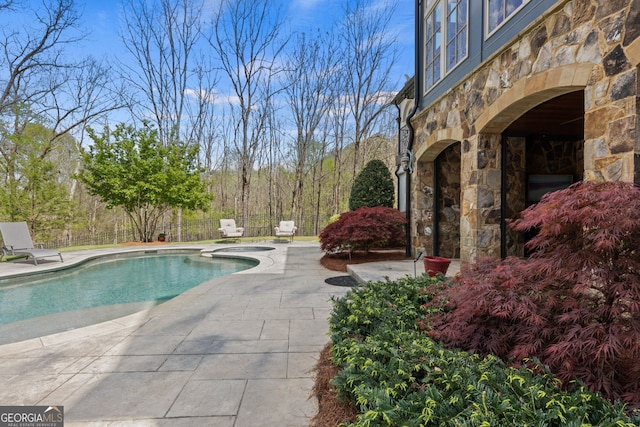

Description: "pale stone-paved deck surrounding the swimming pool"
0 241 455 427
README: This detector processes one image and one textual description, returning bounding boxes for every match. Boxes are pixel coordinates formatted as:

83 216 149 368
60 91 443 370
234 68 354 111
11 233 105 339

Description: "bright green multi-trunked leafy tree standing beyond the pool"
78 124 212 242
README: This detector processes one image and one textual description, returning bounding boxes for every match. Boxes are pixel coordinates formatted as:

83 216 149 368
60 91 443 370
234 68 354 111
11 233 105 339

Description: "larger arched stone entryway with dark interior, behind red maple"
461 64 594 261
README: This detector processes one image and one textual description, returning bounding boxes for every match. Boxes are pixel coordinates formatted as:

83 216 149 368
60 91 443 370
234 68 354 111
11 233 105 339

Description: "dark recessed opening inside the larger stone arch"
501 90 584 257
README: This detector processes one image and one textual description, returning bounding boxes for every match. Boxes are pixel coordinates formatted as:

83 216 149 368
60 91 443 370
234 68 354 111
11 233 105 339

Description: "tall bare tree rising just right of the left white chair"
209 0 286 226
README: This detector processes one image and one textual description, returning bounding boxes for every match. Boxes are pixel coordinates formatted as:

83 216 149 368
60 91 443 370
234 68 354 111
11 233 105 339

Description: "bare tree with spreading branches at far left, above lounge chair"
0 0 121 231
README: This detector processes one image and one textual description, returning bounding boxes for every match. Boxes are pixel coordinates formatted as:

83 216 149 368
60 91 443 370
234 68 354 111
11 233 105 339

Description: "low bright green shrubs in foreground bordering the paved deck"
329 276 640 427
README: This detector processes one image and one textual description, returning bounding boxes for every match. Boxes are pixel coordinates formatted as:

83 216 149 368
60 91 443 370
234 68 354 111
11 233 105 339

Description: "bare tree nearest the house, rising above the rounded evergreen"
339 0 398 176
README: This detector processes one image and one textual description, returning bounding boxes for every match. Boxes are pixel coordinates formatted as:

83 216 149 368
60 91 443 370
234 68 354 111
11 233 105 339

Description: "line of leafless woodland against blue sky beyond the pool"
0 0 408 244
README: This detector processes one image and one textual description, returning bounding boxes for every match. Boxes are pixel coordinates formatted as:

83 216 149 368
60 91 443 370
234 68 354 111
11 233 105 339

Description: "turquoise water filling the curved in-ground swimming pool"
0 253 258 325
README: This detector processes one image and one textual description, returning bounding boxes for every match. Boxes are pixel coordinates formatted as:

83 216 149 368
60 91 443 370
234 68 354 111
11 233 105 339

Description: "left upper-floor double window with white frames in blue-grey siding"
424 0 469 90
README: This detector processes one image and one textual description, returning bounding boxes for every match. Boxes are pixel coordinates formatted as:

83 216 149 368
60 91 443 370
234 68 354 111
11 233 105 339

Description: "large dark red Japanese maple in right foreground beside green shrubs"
423 182 640 408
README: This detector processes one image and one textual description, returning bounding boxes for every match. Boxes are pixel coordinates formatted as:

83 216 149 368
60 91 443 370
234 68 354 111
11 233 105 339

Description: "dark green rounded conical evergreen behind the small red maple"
349 160 395 211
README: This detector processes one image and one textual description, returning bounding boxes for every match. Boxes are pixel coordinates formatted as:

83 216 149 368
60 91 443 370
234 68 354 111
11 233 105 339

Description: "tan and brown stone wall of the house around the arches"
412 0 640 267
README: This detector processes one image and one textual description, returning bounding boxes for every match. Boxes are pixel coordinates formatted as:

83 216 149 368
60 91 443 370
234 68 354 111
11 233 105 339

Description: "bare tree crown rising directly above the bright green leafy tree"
121 0 202 145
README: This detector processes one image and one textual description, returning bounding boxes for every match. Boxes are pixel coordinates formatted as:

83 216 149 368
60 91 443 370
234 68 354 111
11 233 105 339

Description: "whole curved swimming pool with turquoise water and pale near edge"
0 252 258 343
